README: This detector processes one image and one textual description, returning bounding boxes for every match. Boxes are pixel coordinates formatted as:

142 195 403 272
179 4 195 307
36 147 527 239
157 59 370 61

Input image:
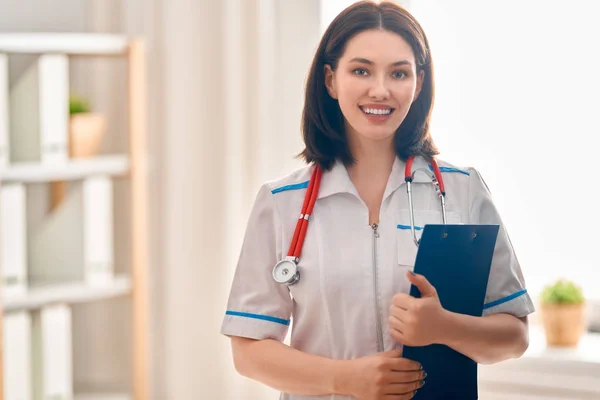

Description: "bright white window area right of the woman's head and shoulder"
410 0 600 298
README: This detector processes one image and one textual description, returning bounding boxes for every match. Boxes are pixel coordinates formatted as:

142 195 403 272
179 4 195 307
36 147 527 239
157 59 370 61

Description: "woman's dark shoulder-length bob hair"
298 0 439 171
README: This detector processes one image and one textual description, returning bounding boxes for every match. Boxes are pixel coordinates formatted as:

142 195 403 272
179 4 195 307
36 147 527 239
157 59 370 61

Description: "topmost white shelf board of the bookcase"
0 33 129 55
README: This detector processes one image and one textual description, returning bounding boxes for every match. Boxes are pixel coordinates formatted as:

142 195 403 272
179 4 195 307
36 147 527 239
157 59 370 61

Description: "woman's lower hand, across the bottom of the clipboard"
338 350 427 400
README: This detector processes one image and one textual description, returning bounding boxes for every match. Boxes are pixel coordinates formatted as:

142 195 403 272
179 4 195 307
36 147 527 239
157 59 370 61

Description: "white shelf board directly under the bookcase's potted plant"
0 155 129 183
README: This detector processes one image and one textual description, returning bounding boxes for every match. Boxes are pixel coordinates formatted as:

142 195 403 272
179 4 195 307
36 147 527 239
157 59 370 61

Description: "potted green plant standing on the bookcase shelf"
69 95 106 158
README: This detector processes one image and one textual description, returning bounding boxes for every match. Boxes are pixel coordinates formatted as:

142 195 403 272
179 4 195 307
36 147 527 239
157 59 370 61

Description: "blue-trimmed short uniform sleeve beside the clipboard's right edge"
469 168 535 318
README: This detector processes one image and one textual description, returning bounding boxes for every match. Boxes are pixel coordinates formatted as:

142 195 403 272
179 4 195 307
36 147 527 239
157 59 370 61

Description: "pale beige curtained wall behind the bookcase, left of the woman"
0 0 320 400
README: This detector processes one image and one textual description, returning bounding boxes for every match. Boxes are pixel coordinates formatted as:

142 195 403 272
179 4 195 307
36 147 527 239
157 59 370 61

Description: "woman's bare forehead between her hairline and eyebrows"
341 30 415 64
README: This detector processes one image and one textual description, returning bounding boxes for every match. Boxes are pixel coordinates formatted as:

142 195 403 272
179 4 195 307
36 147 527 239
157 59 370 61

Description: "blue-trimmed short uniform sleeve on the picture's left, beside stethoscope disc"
221 185 292 341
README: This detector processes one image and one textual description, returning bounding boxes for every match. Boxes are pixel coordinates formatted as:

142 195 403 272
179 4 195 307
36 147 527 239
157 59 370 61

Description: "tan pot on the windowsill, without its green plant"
541 303 585 346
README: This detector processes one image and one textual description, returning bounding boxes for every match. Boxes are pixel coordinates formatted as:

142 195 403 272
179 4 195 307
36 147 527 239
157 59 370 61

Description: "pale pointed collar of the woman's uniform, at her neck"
317 156 431 199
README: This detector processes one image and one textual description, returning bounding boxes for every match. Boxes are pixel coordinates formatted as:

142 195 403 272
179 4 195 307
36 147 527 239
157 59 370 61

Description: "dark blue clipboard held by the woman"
402 225 499 400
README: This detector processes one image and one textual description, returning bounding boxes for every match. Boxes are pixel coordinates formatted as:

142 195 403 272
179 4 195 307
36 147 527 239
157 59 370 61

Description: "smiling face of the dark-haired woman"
325 30 423 145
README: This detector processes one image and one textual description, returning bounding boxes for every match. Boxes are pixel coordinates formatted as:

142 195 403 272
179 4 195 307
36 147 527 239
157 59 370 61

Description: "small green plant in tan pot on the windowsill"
541 279 585 346
